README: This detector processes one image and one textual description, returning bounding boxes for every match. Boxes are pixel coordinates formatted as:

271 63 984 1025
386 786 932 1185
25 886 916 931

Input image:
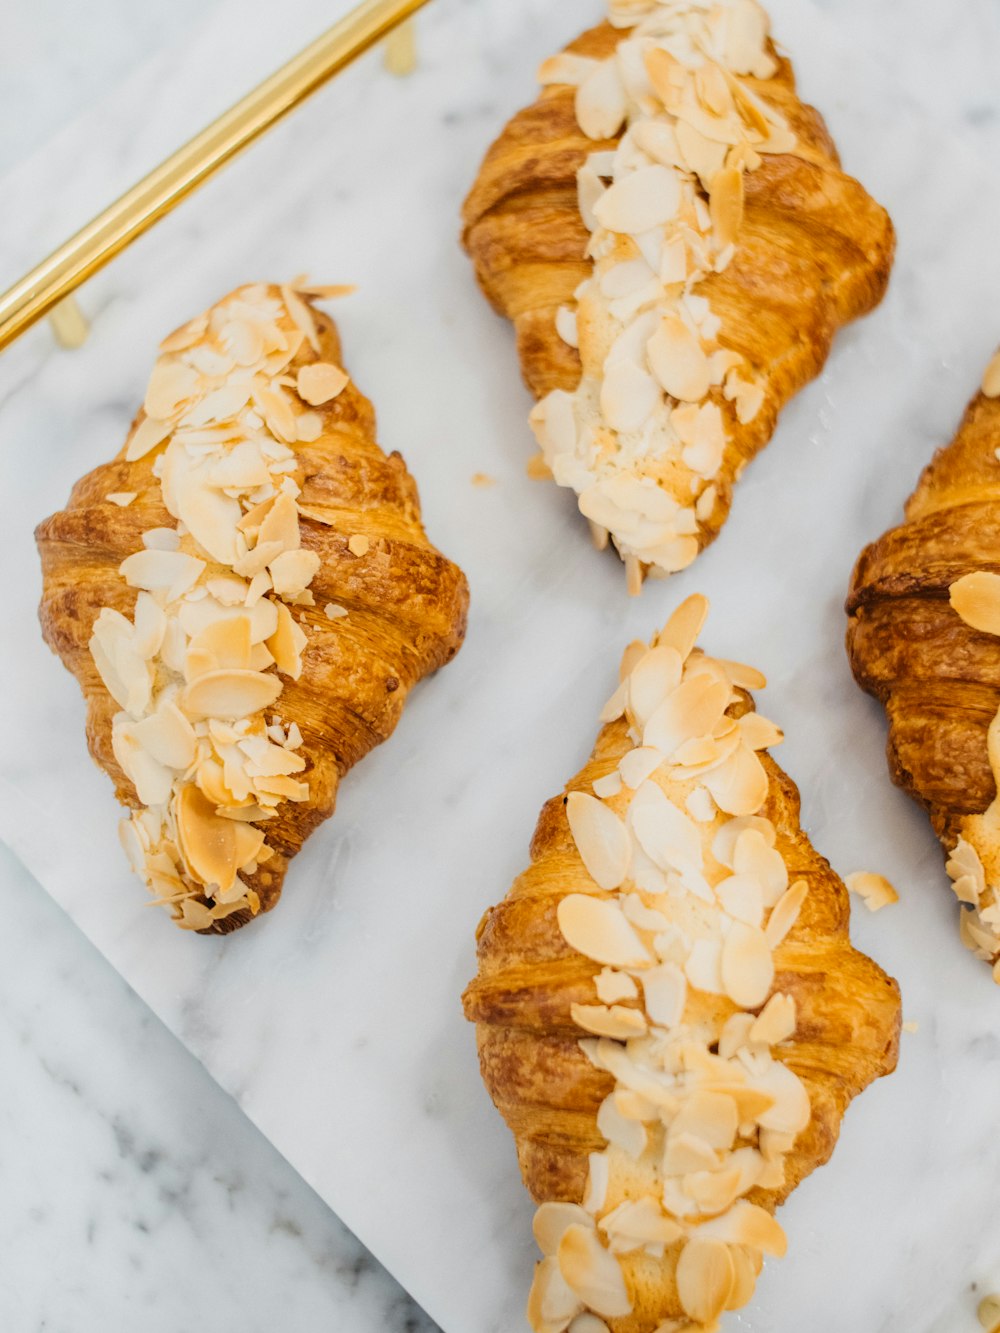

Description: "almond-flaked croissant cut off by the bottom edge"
464 596 900 1333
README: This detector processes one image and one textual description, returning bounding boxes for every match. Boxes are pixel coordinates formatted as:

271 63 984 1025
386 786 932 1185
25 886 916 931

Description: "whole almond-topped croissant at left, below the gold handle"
36 285 468 933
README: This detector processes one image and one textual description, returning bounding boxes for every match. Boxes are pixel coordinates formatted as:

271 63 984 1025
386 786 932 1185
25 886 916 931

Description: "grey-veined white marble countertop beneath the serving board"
0 0 1000 1333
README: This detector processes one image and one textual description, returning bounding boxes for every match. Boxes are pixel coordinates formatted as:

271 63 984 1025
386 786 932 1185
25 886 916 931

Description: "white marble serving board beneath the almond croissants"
0 0 1000 1333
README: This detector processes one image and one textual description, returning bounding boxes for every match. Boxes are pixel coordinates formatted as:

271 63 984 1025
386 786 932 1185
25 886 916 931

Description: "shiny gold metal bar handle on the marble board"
0 0 428 349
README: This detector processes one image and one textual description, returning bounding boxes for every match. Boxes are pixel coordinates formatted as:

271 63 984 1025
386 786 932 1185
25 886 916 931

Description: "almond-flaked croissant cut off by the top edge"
463 0 895 593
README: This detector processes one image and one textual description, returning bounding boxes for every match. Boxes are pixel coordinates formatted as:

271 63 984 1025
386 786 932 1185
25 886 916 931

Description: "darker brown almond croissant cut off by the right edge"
847 353 1000 982
